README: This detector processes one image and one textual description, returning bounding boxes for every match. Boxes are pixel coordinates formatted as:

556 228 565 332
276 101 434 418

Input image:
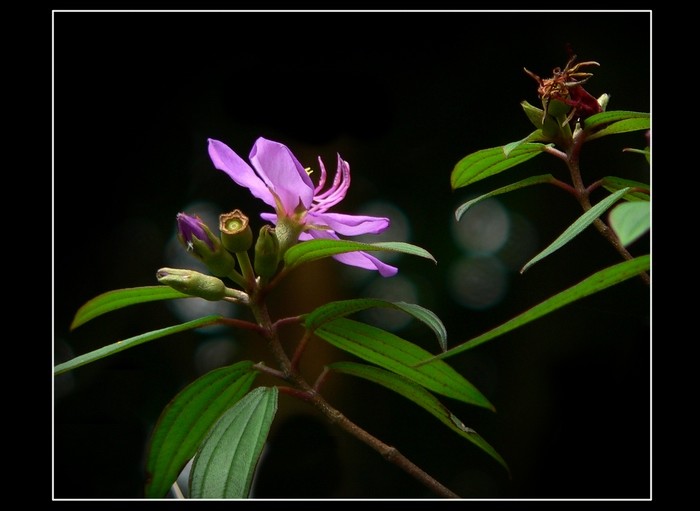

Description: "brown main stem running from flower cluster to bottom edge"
251 296 460 499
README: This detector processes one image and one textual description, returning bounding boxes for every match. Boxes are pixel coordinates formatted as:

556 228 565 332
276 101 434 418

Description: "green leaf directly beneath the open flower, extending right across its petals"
284 239 437 270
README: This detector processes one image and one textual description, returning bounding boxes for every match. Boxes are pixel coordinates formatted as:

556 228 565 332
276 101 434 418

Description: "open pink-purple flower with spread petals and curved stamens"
209 137 398 277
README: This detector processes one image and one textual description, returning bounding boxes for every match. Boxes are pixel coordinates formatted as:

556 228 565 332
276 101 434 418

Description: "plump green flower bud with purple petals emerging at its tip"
177 213 236 277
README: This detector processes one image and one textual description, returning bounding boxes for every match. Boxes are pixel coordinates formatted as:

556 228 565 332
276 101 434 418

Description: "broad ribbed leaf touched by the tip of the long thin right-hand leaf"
315 318 495 410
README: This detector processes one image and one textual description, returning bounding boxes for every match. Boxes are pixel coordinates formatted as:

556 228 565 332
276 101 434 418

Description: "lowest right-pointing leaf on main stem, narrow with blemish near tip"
327 362 510 474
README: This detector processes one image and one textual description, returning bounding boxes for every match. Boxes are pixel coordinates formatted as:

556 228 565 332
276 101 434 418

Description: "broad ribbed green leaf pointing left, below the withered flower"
450 142 547 190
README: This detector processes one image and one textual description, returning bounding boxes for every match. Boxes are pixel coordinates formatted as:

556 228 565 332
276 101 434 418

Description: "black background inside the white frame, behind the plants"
52 12 651 498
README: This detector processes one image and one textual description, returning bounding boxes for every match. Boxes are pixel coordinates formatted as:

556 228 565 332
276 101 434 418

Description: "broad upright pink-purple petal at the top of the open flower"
250 137 314 215
